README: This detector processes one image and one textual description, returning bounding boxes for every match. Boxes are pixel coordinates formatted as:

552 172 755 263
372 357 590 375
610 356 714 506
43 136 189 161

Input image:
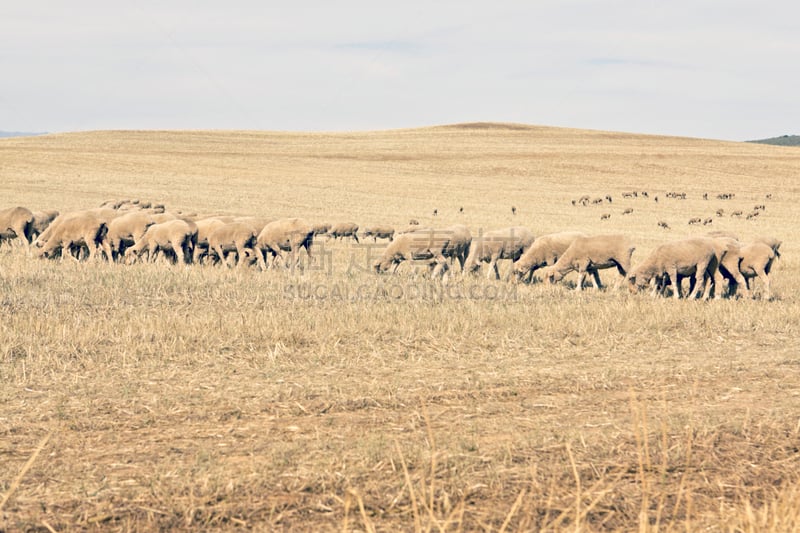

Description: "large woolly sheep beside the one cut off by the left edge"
35 210 111 260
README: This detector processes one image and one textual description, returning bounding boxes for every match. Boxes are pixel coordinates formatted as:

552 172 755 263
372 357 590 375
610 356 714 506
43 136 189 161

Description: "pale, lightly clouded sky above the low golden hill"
0 0 800 140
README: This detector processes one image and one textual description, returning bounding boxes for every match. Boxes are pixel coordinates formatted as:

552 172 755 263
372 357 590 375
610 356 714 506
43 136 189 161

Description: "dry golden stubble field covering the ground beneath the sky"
0 124 800 531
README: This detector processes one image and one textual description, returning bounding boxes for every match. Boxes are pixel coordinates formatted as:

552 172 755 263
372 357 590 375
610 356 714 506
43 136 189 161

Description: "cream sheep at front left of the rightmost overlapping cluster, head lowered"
627 237 720 299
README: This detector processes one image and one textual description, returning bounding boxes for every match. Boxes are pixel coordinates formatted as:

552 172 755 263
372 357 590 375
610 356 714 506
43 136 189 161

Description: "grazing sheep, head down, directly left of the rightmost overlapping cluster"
542 234 635 291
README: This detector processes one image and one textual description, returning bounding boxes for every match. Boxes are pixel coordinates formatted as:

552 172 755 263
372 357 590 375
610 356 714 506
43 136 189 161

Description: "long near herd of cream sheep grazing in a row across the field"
0 200 781 299
